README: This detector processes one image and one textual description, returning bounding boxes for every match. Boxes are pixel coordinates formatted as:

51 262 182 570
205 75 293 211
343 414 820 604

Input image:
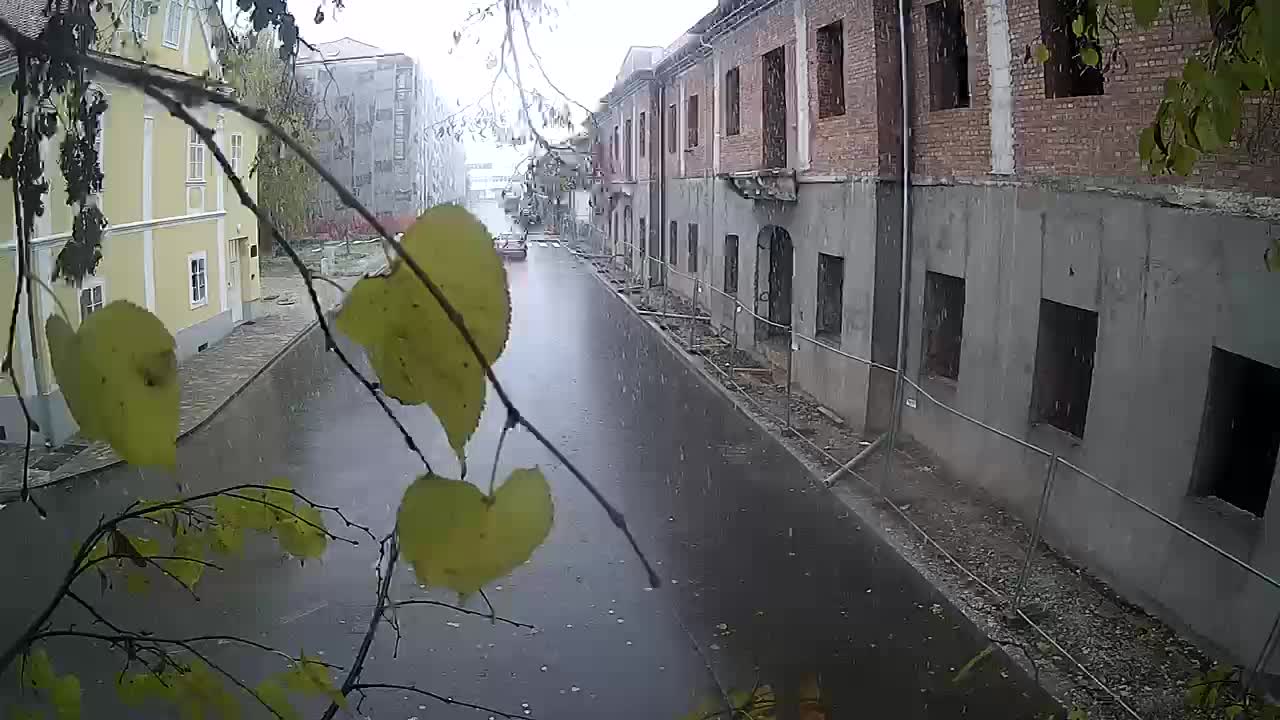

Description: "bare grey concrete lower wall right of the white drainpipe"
904 181 1280 661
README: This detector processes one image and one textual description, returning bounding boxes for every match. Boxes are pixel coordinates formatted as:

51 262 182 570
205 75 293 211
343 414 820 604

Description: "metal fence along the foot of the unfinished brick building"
570 228 1280 720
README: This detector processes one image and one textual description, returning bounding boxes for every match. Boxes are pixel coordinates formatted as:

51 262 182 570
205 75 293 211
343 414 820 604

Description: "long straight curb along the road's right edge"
570 249 1065 710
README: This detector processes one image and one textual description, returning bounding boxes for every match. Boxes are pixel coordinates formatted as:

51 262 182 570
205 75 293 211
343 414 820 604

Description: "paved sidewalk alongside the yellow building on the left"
0 269 358 502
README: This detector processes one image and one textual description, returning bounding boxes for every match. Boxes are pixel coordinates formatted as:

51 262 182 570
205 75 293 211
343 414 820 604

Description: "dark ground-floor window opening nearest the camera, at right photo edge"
1192 347 1280 518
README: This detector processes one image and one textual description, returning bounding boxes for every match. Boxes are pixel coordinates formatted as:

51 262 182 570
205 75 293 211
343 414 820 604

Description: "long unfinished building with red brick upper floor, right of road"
595 0 1280 667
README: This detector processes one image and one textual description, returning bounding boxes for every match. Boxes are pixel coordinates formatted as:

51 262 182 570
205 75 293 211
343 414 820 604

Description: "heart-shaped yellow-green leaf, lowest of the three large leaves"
396 468 554 596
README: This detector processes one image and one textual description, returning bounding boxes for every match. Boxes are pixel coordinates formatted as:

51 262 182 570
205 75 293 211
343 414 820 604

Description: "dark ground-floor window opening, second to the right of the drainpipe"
1032 300 1098 438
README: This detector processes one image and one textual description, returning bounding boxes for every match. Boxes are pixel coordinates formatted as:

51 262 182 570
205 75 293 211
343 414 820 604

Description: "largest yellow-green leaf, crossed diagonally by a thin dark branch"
337 205 511 459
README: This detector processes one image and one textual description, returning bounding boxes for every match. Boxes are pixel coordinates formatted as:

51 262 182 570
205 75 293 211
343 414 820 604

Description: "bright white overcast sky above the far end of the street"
289 0 716 172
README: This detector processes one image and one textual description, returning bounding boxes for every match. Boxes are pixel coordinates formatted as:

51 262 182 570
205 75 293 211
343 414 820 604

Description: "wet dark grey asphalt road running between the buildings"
0 238 1053 720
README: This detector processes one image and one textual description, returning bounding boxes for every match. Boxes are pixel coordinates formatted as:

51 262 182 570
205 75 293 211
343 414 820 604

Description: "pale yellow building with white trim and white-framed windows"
0 0 260 443
